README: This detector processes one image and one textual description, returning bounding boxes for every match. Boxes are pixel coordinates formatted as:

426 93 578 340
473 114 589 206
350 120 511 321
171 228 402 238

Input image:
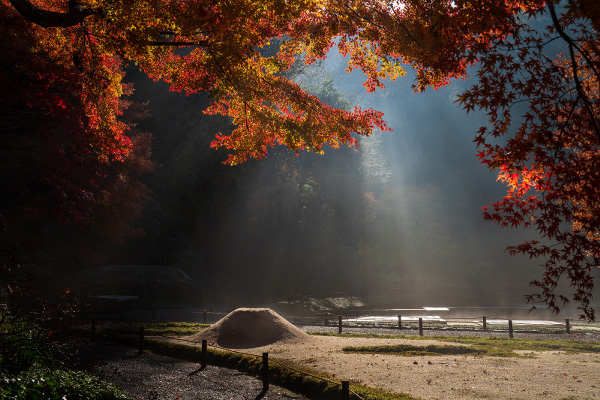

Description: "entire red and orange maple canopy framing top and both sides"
0 0 600 319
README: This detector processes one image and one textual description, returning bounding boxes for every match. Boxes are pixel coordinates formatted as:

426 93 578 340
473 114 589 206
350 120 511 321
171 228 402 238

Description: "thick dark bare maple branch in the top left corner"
9 0 100 28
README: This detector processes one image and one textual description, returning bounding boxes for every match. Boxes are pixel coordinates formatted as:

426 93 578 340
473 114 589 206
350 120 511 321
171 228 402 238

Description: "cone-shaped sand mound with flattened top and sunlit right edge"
192 308 308 349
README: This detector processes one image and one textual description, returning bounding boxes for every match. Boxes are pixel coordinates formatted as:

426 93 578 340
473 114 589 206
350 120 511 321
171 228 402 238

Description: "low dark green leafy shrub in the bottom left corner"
0 366 128 400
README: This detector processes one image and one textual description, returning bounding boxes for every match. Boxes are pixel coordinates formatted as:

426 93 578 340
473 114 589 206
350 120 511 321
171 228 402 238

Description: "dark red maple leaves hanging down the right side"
459 1 600 319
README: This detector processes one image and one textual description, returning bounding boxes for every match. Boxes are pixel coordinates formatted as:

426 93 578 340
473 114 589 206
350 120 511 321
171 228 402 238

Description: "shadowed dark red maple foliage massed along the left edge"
0 0 153 268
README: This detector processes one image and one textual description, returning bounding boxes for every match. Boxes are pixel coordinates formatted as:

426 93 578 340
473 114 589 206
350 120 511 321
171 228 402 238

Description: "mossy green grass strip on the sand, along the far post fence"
311 332 600 357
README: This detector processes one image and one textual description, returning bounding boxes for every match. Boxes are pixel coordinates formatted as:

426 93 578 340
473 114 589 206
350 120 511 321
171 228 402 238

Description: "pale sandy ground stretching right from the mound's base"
219 336 600 400
